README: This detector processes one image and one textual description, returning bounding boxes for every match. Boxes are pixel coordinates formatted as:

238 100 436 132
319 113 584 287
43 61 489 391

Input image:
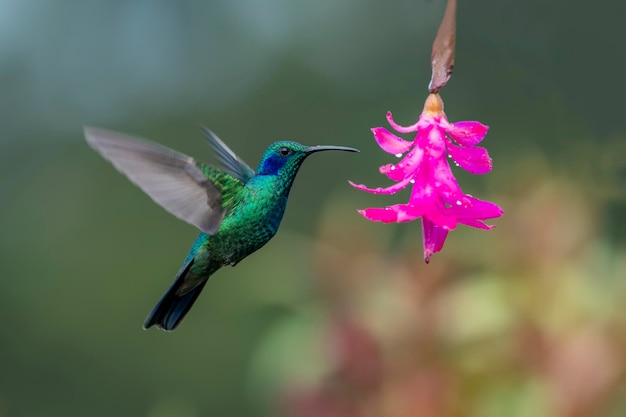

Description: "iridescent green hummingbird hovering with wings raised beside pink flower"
85 127 359 331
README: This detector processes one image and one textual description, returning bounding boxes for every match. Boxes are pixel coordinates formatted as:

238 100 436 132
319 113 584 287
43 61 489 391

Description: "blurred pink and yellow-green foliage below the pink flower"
282 175 626 417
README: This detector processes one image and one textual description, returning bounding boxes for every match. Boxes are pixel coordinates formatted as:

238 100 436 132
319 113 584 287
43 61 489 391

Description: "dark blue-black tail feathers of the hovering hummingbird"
143 257 207 331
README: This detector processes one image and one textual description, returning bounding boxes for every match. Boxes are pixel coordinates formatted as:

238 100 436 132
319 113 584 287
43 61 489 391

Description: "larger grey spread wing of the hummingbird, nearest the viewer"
85 127 225 235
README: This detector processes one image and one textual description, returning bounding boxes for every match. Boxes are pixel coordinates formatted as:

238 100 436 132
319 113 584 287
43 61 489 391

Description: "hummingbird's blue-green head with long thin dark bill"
257 141 359 176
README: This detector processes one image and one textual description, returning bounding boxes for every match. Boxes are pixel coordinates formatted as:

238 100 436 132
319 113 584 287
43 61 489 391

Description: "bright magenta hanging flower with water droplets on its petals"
350 93 503 262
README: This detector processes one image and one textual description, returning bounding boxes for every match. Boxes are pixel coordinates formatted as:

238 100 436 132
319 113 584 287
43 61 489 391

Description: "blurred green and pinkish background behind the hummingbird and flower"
0 0 626 417
